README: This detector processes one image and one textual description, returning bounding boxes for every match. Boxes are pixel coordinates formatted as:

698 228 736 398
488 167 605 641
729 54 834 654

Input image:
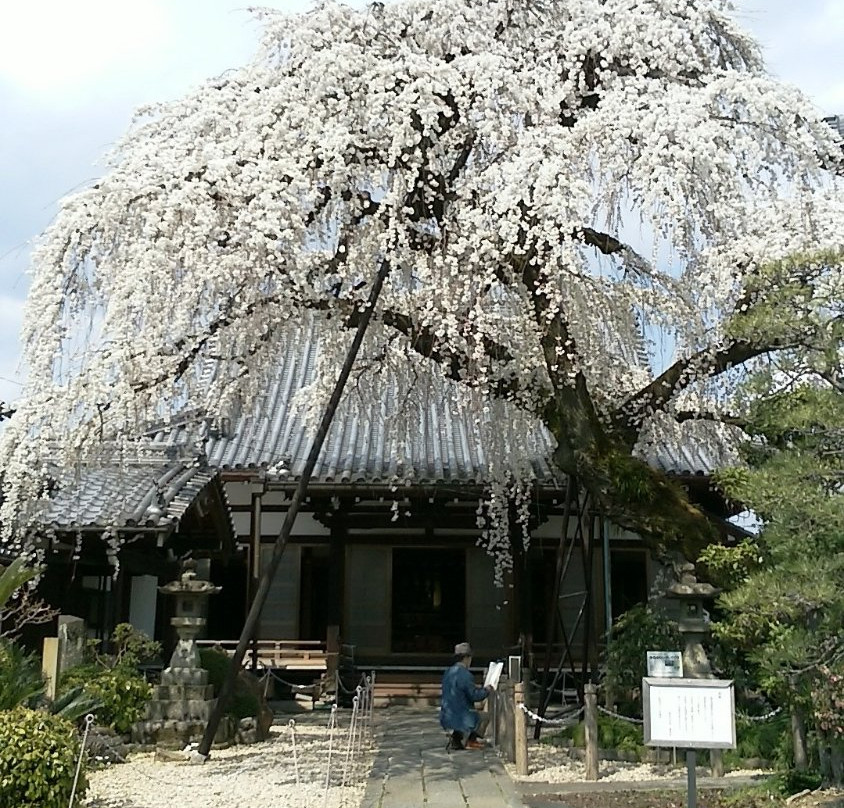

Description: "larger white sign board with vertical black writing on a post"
642 677 736 749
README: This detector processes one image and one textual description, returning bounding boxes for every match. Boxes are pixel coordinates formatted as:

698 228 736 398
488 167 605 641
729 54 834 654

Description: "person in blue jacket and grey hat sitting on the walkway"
440 642 493 749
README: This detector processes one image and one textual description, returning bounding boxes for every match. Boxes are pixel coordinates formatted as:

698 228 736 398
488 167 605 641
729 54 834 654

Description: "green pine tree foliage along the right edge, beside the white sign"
704 246 844 782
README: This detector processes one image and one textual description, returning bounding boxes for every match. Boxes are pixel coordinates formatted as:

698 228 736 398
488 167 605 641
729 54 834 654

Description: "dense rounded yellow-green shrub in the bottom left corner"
0 707 87 808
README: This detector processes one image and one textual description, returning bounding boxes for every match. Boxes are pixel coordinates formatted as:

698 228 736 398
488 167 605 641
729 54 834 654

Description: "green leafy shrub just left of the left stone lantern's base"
59 665 152 733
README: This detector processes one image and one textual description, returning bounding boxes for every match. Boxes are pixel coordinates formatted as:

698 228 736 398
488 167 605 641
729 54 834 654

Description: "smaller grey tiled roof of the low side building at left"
40 449 221 531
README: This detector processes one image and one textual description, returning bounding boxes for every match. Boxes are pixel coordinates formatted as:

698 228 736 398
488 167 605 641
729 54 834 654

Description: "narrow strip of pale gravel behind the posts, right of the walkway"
505 740 770 783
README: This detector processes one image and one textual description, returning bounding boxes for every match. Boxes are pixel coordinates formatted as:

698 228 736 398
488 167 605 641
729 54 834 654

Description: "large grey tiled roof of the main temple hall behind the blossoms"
156 325 735 486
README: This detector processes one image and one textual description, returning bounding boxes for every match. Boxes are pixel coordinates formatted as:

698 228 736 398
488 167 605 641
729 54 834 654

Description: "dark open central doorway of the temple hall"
390 548 466 653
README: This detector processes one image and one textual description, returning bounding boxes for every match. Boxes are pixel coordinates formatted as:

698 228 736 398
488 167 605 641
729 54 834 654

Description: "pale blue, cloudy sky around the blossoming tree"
0 0 844 402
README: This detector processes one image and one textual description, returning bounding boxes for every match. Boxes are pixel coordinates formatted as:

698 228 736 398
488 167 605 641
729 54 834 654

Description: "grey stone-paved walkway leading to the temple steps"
361 707 523 808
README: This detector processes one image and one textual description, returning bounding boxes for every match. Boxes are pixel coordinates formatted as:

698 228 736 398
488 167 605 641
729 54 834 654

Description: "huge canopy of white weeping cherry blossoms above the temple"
0 0 844 572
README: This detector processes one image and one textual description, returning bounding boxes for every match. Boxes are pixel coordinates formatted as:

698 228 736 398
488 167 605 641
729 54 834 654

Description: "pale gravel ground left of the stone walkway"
85 712 372 808
